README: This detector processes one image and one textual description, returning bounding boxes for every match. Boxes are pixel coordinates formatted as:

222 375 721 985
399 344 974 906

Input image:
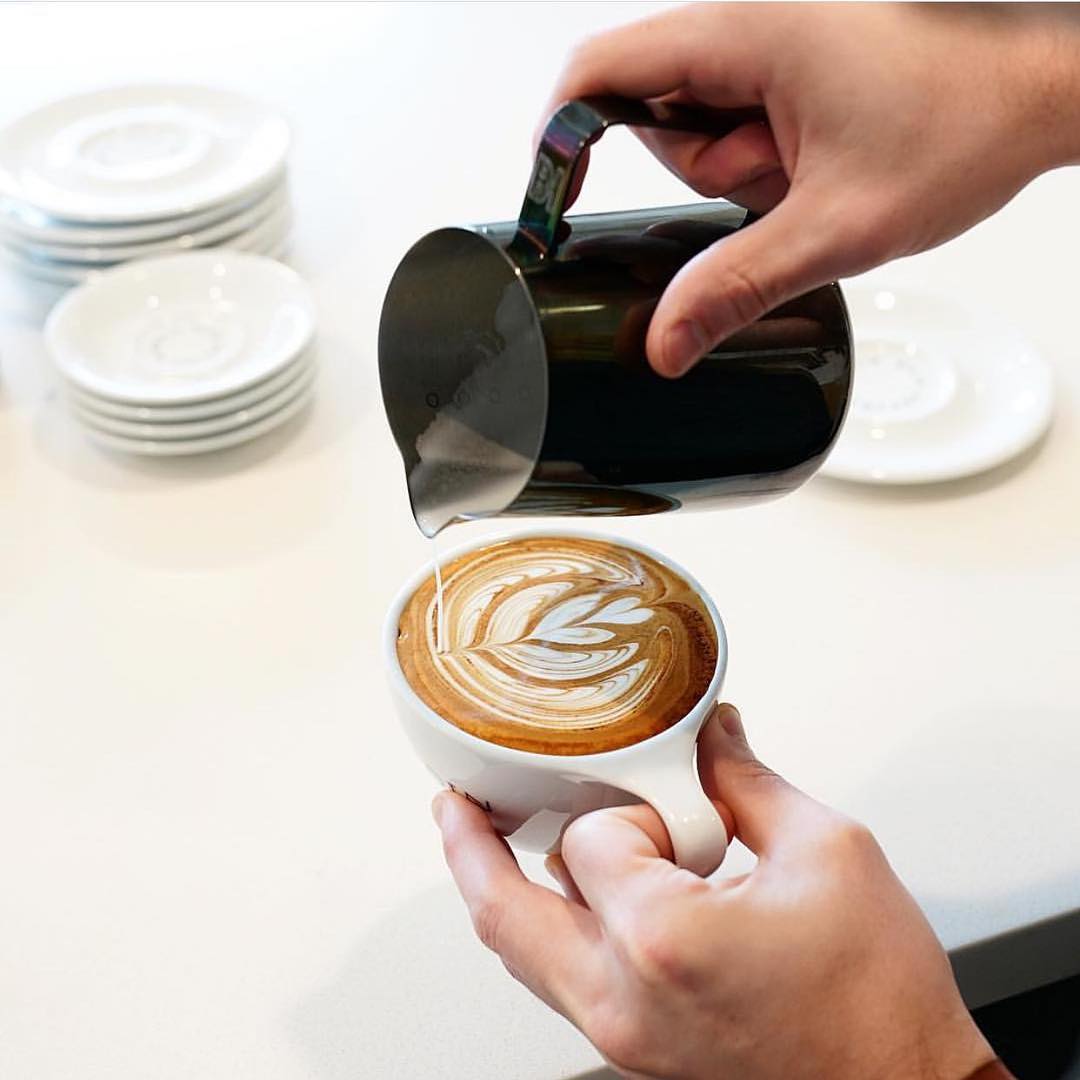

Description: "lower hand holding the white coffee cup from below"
434 705 994 1080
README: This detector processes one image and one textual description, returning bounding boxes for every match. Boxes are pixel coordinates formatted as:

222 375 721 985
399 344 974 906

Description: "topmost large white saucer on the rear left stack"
0 84 288 225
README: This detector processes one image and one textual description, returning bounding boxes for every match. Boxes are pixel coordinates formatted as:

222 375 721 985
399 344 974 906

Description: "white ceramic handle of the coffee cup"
616 740 729 877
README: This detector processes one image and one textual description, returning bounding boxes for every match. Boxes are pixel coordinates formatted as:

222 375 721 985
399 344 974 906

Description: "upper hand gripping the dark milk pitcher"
549 3 1080 376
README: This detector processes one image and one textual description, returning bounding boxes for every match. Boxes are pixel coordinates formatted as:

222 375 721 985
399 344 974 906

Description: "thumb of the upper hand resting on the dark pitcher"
645 188 852 378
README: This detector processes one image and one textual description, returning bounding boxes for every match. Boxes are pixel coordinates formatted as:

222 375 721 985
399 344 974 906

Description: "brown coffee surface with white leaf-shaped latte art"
397 536 718 754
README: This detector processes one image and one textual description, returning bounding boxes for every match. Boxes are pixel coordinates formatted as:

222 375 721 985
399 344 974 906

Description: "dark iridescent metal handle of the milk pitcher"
510 96 766 266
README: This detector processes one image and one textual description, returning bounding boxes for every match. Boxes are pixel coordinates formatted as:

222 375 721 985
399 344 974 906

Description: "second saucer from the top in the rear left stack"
0 170 286 246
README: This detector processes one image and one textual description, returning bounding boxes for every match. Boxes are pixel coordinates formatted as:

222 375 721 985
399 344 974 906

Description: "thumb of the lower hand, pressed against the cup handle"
698 705 831 856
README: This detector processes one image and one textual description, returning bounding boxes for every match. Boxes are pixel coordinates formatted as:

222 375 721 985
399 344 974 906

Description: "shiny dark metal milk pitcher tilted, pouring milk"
379 97 852 536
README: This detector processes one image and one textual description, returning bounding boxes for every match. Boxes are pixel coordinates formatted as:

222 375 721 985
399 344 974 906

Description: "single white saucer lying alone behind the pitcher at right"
821 284 1053 484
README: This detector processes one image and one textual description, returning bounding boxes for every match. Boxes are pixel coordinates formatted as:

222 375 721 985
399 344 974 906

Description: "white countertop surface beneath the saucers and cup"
0 4 1080 1080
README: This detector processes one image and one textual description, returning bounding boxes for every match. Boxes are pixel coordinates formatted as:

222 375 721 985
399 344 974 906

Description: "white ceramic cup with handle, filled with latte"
383 528 728 875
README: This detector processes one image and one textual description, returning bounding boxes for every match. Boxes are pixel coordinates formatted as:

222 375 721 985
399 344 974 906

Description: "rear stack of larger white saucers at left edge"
0 85 291 284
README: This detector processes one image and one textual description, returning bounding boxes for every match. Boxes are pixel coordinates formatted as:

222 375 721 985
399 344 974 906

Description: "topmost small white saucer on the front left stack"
45 251 315 405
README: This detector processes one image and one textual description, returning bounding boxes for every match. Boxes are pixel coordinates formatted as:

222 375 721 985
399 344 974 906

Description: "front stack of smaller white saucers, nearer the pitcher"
45 252 315 457
